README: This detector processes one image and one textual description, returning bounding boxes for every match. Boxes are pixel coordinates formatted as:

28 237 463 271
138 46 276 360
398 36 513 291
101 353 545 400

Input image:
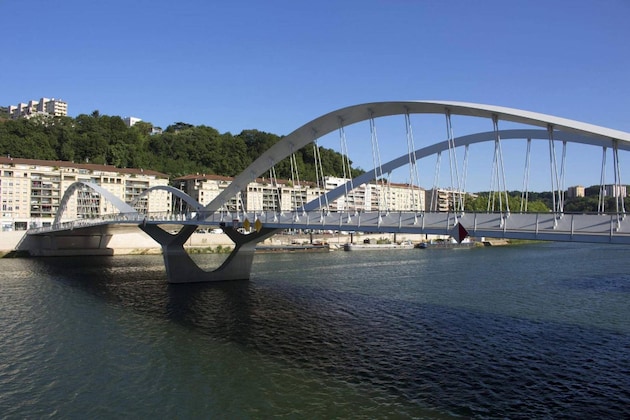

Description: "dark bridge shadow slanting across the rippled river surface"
33 257 630 418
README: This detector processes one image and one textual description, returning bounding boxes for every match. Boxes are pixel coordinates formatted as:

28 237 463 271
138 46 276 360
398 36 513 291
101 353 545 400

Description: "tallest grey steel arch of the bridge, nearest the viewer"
204 101 630 212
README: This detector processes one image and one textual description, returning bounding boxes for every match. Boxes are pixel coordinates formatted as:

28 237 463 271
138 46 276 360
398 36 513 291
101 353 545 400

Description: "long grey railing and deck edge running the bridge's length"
28 210 630 243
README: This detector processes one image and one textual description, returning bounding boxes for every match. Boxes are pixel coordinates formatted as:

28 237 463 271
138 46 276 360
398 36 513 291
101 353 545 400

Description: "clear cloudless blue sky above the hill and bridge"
0 0 630 190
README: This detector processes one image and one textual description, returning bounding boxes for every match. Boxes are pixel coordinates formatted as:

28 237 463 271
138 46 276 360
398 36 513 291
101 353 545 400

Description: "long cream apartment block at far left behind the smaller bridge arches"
0 157 171 231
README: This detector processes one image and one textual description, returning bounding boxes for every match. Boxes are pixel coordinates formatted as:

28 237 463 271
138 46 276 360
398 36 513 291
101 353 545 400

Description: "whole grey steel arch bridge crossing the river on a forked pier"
19 101 630 283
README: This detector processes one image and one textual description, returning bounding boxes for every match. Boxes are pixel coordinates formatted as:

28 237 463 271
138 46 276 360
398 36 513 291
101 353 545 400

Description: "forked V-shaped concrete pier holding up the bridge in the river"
140 224 277 283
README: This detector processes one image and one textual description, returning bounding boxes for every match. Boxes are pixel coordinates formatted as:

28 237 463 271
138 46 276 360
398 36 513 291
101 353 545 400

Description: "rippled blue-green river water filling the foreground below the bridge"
0 243 630 419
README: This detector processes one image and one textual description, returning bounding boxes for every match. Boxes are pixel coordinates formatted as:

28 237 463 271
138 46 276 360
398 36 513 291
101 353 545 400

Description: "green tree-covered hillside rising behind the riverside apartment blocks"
0 111 362 181
